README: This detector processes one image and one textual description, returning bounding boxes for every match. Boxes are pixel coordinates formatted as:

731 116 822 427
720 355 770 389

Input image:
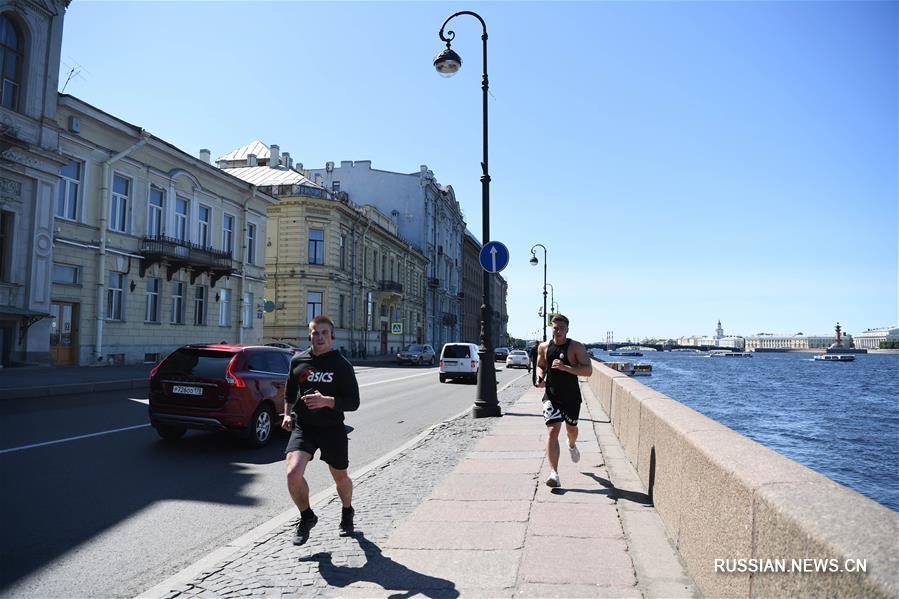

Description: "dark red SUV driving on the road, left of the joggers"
150 344 292 447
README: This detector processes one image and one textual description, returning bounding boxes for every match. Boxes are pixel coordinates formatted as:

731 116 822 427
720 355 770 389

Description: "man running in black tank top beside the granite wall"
535 314 593 487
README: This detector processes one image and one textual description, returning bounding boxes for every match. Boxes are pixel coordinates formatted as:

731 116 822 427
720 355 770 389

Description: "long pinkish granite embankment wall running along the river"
589 362 899 598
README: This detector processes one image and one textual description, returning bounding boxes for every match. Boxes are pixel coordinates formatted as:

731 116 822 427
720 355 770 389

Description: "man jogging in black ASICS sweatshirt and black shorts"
281 316 359 545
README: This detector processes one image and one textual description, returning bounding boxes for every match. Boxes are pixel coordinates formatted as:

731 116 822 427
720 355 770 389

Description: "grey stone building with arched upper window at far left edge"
0 0 69 366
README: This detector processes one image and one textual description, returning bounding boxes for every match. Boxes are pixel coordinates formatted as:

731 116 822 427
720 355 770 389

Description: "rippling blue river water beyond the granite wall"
597 352 899 511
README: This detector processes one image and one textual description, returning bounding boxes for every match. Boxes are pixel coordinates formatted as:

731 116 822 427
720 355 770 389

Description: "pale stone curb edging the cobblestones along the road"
135 375 525 599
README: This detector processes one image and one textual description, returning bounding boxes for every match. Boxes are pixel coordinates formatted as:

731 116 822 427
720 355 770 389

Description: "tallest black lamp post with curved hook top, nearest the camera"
434 10 502 418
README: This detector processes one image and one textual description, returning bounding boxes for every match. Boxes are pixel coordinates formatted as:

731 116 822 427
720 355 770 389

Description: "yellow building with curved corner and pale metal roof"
216 140 427 356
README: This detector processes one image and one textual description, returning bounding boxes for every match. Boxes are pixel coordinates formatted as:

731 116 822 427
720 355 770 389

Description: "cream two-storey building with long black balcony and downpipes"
50 94 276 365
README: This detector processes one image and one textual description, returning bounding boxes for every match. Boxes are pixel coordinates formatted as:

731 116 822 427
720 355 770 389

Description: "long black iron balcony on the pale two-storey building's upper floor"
139 237 234 287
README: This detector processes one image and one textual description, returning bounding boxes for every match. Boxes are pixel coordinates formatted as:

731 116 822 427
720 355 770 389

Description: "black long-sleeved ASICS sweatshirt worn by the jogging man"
284 348 359 426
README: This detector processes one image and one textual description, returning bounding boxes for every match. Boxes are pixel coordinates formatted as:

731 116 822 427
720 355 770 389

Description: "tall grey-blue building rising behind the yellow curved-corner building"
303 160 465 349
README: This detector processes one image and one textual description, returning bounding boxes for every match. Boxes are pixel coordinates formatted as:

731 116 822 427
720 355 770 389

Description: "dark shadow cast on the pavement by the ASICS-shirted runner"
299 532 459 599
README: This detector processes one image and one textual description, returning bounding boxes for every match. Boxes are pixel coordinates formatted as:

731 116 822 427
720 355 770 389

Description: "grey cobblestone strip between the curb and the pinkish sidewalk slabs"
164 377 530 599
